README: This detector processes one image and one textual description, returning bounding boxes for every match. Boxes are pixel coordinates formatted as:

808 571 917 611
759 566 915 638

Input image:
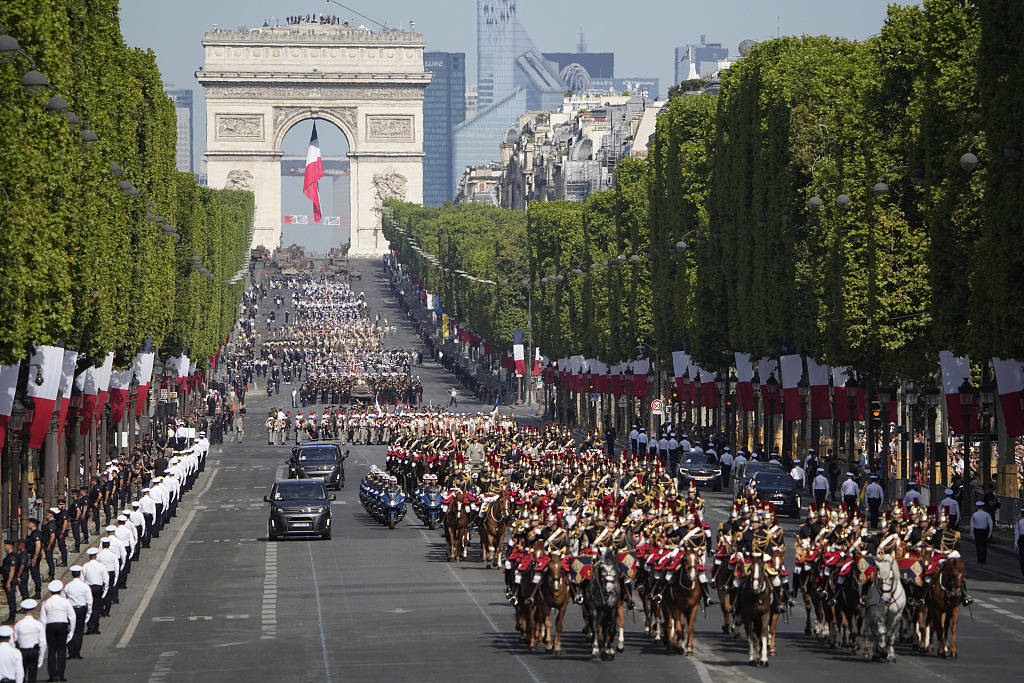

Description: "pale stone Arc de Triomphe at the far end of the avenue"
196 24 431 255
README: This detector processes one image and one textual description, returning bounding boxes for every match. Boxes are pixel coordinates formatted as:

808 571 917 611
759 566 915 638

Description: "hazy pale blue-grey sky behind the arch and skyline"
121 0 916 250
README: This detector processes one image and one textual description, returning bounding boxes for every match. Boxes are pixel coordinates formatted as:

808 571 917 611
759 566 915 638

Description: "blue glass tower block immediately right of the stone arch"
423 52 466 206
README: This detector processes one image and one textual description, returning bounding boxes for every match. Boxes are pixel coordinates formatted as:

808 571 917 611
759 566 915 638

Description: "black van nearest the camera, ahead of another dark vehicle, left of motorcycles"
263 479 336 541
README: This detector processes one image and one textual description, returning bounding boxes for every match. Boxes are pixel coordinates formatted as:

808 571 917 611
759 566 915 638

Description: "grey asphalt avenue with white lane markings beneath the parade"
69 262 1024 683
